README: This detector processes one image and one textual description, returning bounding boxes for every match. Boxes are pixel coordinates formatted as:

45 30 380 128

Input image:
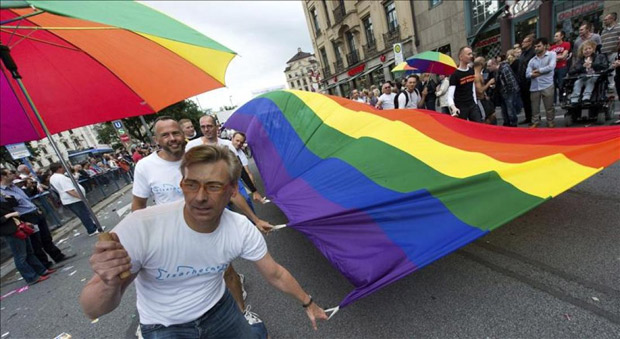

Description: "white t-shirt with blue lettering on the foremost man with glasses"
113 201 267 326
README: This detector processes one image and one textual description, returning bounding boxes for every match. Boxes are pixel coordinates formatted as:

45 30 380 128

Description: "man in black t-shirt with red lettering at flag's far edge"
448 46 482 122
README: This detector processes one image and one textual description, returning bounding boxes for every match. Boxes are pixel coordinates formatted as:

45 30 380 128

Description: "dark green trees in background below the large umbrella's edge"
97 100 204 147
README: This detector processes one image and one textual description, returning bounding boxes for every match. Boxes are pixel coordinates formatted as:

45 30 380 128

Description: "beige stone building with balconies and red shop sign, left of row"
303 0 416 96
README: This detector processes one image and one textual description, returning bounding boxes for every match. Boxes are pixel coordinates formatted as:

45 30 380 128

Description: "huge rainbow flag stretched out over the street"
226 91 620 308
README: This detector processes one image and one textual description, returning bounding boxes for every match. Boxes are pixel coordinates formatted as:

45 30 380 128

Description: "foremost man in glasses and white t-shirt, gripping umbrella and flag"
80 146 327 338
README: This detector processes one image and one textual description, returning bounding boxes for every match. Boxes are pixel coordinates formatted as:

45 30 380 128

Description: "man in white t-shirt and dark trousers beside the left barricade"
49 162 97 235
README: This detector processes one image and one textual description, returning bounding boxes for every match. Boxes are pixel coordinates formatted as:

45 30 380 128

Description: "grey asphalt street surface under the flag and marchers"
0 115 620 339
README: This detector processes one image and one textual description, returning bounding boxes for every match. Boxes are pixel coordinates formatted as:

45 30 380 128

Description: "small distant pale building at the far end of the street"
284 48 320 92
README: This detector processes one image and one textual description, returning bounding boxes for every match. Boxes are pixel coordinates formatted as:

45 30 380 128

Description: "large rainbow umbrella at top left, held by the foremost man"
0 0 235 231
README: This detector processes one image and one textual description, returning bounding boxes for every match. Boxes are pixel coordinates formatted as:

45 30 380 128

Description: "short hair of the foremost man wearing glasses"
181 145 241 184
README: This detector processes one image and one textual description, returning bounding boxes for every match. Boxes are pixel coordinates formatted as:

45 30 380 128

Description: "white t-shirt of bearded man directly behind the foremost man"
131 152 183 205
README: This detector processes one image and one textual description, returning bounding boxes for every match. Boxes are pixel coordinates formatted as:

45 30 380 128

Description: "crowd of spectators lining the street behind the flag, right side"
350 12 620 128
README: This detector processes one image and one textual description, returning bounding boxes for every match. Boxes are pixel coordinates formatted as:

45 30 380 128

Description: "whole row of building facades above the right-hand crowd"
303 0 620 96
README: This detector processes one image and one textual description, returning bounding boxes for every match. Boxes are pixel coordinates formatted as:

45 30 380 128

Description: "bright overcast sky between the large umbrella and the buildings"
144 1 313 109
